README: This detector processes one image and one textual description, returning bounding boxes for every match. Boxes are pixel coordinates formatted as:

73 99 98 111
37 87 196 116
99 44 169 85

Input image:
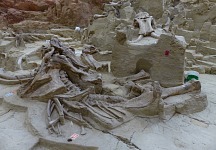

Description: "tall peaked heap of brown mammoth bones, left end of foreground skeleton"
18 38 102 99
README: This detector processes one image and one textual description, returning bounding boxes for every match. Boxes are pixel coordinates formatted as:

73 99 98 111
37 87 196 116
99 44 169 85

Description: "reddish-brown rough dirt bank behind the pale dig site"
0 0 109 28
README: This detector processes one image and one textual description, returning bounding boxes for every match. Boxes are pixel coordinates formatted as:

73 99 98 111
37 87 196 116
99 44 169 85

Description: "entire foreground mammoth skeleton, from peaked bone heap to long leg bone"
8 38 202 135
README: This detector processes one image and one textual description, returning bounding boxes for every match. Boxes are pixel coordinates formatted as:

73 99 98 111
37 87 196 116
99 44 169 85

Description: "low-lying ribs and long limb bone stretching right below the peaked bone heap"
44 77 202 134
